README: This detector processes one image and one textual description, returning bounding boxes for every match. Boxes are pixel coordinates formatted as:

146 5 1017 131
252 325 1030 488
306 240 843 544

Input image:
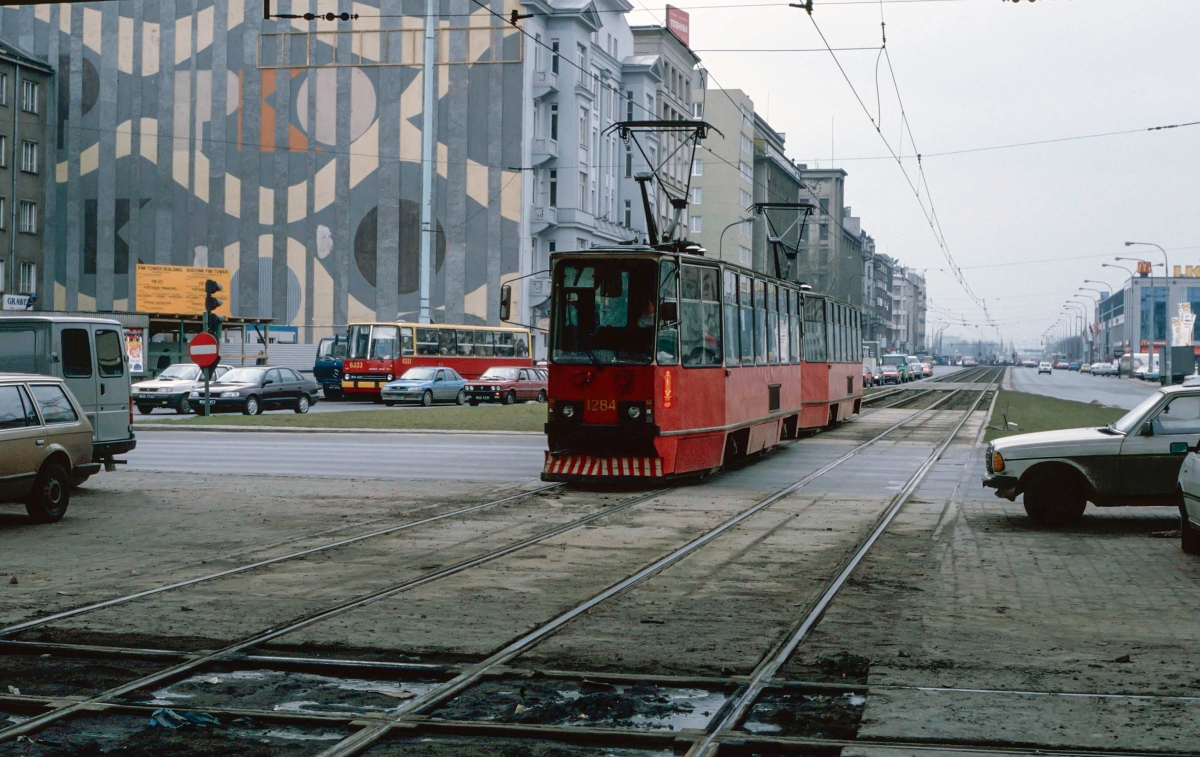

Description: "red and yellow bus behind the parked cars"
342 323 533 398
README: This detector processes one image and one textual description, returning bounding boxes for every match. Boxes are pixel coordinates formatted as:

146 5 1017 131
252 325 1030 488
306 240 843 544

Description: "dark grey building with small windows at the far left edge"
0 38 55 308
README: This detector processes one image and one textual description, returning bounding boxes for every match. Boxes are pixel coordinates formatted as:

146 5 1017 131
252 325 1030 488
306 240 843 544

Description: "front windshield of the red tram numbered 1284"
551 259 658 365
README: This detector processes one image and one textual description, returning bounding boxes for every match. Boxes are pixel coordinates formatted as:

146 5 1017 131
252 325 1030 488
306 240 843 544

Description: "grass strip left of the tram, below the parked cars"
134 403 546 431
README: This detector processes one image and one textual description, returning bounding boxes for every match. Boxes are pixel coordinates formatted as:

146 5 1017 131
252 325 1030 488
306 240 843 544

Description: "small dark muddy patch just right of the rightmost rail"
742 690 866 739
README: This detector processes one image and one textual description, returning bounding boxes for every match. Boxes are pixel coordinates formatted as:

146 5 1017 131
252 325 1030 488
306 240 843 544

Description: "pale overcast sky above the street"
630 0 1200 346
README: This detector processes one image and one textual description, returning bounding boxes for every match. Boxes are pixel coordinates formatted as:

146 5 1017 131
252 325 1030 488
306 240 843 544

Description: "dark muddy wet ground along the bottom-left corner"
0 715 350 757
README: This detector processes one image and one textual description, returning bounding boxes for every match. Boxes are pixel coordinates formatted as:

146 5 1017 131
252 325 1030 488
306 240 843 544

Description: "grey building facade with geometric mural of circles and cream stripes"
0 0 523 341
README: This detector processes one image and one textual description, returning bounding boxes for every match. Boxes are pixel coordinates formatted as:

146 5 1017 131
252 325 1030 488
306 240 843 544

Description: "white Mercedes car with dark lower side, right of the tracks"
983 386 1200 525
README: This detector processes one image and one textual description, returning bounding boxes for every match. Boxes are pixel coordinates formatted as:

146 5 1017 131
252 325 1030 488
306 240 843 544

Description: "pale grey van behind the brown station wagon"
0 314 137 470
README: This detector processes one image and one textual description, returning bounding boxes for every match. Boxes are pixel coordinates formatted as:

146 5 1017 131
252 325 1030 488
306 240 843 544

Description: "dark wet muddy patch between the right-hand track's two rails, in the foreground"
433 679 728 731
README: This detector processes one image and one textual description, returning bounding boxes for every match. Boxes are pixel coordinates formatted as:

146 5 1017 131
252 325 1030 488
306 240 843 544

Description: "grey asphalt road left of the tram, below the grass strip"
126 431 546 481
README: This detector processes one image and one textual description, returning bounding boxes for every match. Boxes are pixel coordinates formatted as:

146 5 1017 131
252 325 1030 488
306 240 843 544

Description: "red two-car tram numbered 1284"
542 246 862 482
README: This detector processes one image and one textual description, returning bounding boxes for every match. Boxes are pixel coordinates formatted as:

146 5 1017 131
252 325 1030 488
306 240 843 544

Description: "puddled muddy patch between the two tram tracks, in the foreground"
127 671 438 715
